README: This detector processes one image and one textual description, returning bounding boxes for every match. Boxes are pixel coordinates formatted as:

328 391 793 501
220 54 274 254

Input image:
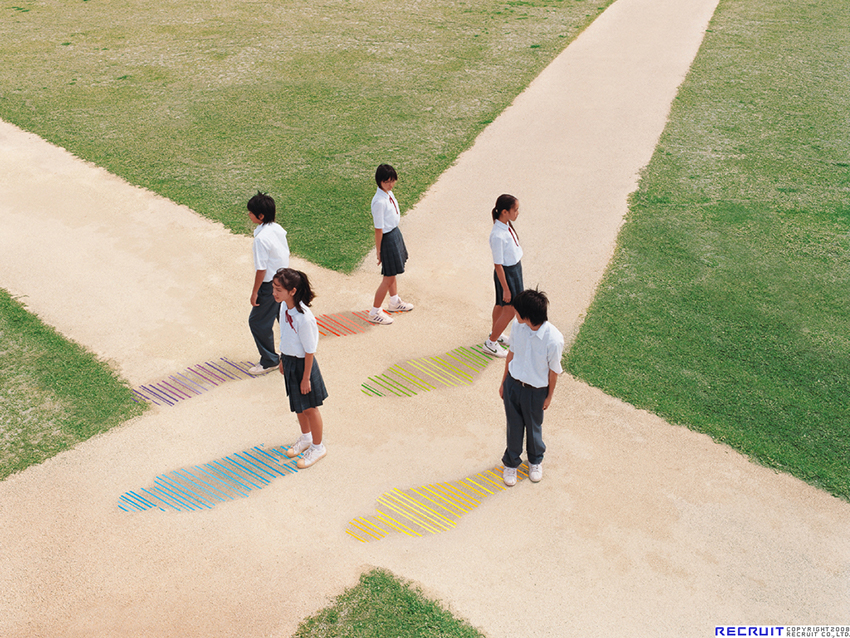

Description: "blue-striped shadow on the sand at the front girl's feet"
118 445 301 512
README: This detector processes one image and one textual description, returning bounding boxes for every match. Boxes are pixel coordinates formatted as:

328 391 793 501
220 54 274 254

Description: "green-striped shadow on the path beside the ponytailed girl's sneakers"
361 345 503 397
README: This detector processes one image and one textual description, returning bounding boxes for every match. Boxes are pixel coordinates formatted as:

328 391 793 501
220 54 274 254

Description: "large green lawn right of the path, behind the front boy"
567 0 850 499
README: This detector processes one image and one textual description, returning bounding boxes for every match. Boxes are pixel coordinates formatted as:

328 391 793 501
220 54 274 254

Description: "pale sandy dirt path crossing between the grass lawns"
0 0 850 638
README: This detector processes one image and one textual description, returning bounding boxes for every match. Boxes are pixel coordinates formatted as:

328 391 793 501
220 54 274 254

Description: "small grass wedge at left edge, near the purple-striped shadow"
0 290 145 479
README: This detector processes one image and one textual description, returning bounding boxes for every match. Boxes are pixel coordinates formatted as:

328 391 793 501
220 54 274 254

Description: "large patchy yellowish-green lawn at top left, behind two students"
0 0 613 271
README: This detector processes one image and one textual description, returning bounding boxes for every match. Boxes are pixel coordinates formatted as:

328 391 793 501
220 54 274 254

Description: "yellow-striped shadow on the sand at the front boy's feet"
345 463 528 543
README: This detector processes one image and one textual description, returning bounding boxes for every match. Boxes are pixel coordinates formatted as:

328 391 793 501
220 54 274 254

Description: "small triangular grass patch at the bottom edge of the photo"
293 569 483 638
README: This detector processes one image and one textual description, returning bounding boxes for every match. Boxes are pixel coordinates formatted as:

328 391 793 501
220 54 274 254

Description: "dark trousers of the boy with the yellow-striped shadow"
502 374 549 467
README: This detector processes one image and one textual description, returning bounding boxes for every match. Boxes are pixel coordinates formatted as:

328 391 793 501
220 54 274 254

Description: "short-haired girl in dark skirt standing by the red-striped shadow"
367 164 413 326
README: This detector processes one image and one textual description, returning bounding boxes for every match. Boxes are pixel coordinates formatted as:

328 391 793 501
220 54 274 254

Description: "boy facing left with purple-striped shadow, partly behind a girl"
248 191 289 374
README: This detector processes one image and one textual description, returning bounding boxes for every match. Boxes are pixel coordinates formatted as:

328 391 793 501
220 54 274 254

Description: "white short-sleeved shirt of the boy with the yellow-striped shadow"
508 319 564 388
